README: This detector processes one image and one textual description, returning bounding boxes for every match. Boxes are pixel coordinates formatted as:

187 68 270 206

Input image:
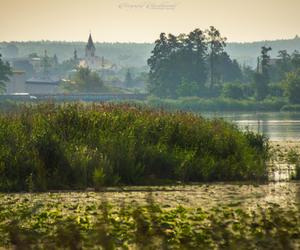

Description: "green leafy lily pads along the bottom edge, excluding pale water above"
0 193 300 249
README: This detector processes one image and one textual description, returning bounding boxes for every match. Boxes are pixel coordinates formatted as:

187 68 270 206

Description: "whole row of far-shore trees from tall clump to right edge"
148 27 300 103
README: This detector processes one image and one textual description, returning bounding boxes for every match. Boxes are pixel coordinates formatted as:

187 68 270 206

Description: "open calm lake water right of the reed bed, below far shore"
202 112 300 141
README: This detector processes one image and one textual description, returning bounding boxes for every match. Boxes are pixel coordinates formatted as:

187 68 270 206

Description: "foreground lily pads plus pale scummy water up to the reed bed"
0 182 300 249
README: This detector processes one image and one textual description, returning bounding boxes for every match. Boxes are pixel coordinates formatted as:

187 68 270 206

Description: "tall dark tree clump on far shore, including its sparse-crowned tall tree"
148 27 243 97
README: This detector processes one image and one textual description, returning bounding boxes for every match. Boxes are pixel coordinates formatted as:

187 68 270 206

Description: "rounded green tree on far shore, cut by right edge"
284 70 300 104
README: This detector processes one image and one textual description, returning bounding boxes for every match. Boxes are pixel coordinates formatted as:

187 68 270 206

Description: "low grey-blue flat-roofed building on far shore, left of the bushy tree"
25 77 60 94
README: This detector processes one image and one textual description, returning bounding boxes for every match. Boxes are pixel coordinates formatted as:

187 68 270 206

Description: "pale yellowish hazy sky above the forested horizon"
0 0 300 42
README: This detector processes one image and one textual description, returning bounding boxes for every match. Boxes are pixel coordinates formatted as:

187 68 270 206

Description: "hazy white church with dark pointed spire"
76 34 116 71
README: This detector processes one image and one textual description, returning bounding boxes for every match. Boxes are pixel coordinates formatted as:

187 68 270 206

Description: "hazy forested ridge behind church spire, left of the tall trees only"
0 41 153 67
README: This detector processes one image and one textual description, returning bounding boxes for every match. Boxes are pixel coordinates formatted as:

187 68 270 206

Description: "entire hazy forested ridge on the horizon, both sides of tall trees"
0 36 300 67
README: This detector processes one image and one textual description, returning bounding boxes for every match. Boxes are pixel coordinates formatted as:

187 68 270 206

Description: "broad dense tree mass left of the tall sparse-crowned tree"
148 29 207 97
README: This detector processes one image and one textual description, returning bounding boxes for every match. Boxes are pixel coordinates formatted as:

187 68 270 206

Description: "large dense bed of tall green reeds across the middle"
0 104 268 191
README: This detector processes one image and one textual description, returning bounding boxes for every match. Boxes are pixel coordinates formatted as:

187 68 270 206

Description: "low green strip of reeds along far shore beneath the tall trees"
147 97 287 112
